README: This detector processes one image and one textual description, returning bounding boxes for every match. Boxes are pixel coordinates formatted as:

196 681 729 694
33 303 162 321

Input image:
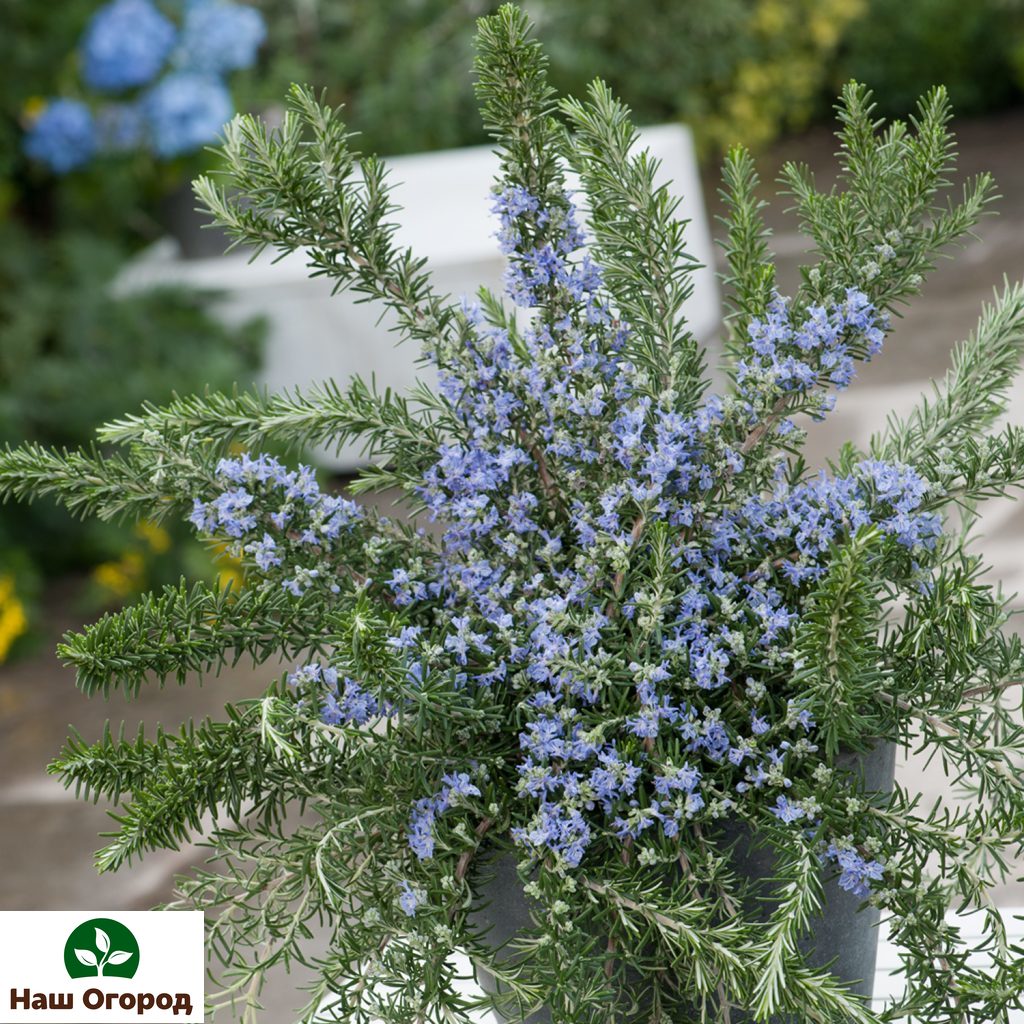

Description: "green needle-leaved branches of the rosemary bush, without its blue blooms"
0 6 1024 1024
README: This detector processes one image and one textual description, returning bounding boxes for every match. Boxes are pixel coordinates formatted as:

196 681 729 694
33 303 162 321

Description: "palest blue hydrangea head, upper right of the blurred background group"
175 0 266 75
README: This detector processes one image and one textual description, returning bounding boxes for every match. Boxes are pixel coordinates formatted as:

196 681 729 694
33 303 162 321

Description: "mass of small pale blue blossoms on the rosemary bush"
186 182 940 905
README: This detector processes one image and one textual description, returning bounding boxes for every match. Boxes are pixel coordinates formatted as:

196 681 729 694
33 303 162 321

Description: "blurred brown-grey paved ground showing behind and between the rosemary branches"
0 103 1024 1022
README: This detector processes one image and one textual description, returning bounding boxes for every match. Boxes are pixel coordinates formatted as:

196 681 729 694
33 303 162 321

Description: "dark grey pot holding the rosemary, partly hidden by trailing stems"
470 743 896 1024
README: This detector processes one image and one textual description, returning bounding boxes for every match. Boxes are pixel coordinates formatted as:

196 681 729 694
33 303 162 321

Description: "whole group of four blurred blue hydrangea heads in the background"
26 0 266 174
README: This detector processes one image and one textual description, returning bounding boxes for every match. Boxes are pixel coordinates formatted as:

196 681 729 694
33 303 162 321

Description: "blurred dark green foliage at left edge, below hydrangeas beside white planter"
0 224 262 598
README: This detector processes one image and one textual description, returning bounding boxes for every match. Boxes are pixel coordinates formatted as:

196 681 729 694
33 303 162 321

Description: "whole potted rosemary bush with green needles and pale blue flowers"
0 6 1024 1024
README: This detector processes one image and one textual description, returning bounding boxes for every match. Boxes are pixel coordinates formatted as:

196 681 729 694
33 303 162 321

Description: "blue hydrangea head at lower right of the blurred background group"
142 71 233 157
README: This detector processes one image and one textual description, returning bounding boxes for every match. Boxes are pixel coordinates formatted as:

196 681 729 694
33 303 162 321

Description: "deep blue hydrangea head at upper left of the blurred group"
82 0 177 92
